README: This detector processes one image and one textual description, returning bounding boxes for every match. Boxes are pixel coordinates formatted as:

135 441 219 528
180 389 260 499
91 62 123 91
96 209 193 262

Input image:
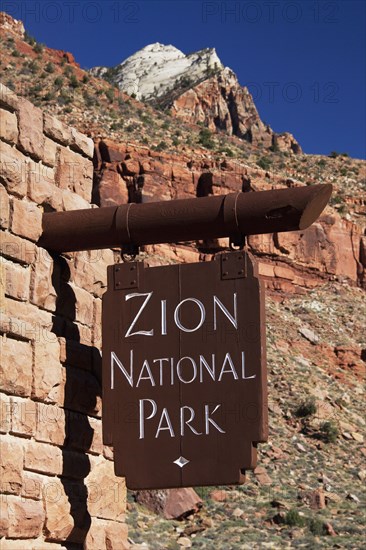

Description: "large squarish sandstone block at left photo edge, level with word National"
0 336 32 396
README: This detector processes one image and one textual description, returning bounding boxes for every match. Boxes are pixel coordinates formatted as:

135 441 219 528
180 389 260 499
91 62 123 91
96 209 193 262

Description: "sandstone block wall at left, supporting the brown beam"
0 86 128 550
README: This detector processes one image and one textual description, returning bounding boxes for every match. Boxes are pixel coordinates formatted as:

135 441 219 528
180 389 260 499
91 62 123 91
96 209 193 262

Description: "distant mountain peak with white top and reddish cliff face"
90 42 301 154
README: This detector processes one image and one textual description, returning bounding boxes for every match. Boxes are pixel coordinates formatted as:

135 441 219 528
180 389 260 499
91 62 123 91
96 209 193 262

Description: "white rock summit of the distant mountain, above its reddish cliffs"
91 42 224 100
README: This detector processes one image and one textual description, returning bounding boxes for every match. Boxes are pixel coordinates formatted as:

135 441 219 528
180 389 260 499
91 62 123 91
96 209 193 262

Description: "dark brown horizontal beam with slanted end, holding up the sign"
38 184 332 252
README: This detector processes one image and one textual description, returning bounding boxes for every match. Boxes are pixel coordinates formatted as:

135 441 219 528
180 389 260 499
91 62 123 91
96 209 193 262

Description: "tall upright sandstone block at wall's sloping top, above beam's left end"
18 98 44 160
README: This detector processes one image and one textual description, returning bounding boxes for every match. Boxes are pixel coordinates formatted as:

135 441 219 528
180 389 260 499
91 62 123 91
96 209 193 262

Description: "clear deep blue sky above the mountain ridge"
0 0 366 158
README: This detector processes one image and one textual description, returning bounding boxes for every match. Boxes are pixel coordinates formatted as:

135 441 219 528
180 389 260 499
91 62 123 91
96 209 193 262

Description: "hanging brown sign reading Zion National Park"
103 252 268 489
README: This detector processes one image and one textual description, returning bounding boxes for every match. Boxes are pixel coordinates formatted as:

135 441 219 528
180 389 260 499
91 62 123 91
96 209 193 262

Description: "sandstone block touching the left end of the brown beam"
11 199 42 241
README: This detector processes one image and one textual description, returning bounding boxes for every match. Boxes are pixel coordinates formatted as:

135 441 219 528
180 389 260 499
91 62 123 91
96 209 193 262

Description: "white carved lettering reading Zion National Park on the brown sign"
110 292 256 439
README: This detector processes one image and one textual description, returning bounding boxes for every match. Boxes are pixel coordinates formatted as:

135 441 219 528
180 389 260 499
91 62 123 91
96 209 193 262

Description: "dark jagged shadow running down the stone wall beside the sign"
52 254 101 550
